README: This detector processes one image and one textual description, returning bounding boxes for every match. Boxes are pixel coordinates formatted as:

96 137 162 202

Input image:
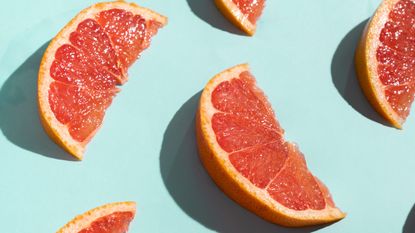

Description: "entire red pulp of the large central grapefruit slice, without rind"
212 71 334 210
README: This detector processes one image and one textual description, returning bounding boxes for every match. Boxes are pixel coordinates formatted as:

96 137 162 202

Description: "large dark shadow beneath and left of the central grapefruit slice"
160 92 324 233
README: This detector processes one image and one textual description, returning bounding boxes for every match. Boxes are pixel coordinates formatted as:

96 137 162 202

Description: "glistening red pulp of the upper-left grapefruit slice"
49 9 161 142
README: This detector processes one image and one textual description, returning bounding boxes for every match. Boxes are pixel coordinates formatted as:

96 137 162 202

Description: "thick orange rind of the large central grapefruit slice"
196 64 346 227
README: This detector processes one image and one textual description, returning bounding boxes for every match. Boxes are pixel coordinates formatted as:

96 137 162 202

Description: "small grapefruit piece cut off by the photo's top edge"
215 0 265 36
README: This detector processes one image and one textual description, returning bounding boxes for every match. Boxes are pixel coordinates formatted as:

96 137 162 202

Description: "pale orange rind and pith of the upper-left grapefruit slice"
38 1 167 160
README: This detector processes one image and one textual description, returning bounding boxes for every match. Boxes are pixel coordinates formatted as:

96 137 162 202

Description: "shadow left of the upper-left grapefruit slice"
0 41 75 161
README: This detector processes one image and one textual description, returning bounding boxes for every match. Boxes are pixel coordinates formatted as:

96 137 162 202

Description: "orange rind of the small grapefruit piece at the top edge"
215 0 256 36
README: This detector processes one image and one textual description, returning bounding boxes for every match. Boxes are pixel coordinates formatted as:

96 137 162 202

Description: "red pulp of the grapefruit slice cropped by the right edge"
376 0 415 119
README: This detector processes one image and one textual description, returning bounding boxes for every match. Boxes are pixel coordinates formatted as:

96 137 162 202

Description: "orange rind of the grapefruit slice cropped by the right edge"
355 0 405 129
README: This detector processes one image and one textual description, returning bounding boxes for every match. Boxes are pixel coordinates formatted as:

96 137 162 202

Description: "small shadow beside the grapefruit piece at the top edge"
187 0 246 36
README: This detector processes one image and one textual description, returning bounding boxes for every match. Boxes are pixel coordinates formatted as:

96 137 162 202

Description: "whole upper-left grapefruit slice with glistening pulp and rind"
38 1 167 159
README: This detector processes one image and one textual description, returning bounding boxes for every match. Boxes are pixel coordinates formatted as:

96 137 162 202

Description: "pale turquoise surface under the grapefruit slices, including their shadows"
0 0 415 233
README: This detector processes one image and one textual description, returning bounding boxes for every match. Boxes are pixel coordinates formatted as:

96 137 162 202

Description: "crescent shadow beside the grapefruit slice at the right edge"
331 19 390 126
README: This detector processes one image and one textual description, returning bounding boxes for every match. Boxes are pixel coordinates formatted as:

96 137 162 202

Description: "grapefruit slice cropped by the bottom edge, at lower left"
57 202 136 233
